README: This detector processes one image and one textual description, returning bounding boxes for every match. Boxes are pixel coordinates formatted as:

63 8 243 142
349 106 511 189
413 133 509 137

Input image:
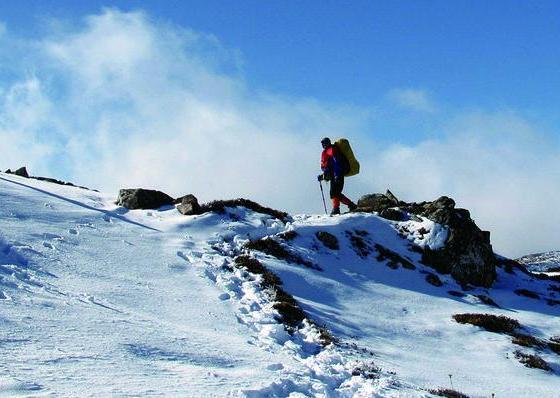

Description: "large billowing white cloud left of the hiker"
0 9 376 216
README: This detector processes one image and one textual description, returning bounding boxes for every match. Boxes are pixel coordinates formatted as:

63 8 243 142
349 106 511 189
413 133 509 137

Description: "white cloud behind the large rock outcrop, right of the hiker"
360 113 560 256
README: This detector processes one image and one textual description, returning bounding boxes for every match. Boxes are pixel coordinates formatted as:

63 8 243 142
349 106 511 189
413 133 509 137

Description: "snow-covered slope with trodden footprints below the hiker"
0 174 560 397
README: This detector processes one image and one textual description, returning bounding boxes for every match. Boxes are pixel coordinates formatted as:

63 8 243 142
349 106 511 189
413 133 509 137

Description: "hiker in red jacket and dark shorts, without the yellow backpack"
317 137 357 216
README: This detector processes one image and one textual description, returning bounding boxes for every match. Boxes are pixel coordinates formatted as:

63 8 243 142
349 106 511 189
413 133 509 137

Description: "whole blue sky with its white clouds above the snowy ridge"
0 0 560 254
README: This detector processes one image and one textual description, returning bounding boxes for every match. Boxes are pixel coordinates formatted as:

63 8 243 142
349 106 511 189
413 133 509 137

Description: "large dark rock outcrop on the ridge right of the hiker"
358 191 496 287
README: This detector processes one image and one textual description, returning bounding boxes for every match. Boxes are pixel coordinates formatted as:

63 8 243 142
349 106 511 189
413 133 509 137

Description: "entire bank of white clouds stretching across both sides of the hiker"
0 9 560 255
